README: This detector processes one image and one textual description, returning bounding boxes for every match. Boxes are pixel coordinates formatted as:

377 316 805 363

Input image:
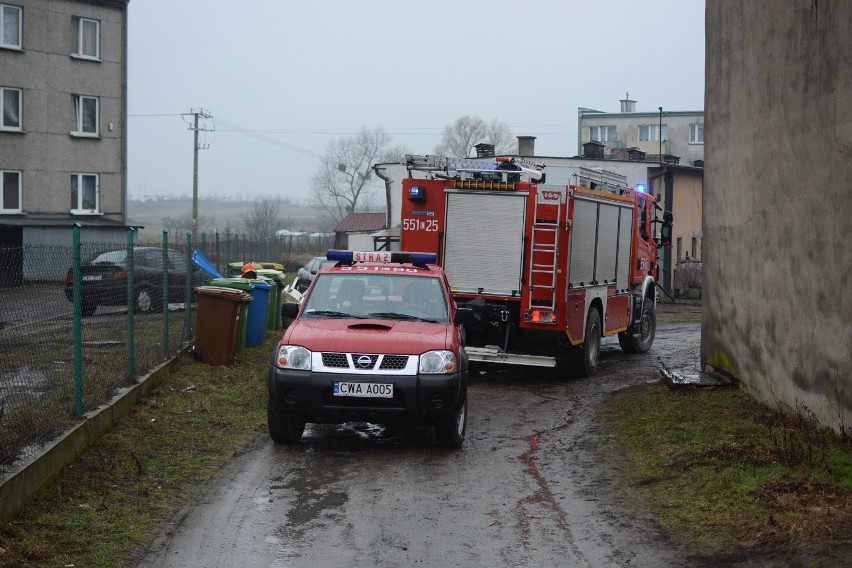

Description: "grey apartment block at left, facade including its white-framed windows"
0 0 128 277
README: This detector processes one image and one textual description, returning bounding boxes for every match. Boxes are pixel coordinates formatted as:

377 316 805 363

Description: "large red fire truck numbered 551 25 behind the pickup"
401 155 672 377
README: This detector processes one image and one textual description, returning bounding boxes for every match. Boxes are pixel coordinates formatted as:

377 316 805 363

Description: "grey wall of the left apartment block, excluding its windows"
0 0 127 222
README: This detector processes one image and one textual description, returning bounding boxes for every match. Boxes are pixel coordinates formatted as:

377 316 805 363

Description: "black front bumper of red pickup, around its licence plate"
268 365 467 424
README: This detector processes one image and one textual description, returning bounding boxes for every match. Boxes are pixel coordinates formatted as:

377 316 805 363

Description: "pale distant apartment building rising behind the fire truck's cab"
577 96 704 167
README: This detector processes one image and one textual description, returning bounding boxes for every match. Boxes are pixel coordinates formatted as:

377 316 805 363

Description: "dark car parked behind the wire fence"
65 247 206 316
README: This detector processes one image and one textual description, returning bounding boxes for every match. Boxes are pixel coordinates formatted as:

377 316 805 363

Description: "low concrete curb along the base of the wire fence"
0 355 183 522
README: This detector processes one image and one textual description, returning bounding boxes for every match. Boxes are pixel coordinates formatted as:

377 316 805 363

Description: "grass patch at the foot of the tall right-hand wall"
598 384 852 555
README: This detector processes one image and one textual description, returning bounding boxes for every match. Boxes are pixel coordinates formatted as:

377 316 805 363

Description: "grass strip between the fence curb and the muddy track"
0 334 277 567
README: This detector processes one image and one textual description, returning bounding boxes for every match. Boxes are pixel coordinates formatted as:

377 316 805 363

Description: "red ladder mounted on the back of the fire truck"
527 186 566 318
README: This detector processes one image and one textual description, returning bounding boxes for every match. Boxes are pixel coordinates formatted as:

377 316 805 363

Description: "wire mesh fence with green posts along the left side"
0 227 324 470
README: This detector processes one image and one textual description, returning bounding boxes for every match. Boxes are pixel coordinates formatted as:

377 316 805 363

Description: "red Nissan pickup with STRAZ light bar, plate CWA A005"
267 250 472 448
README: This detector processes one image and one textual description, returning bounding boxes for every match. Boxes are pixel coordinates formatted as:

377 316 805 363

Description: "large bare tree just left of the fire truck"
312 128 405 224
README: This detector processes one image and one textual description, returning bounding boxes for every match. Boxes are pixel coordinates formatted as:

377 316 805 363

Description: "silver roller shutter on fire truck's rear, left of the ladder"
443 192 527 296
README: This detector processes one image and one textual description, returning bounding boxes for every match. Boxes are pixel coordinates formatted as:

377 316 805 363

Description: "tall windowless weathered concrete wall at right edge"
701 0 852 432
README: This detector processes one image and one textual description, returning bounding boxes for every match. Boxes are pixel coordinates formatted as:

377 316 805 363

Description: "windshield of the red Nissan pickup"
302 272 449 324
